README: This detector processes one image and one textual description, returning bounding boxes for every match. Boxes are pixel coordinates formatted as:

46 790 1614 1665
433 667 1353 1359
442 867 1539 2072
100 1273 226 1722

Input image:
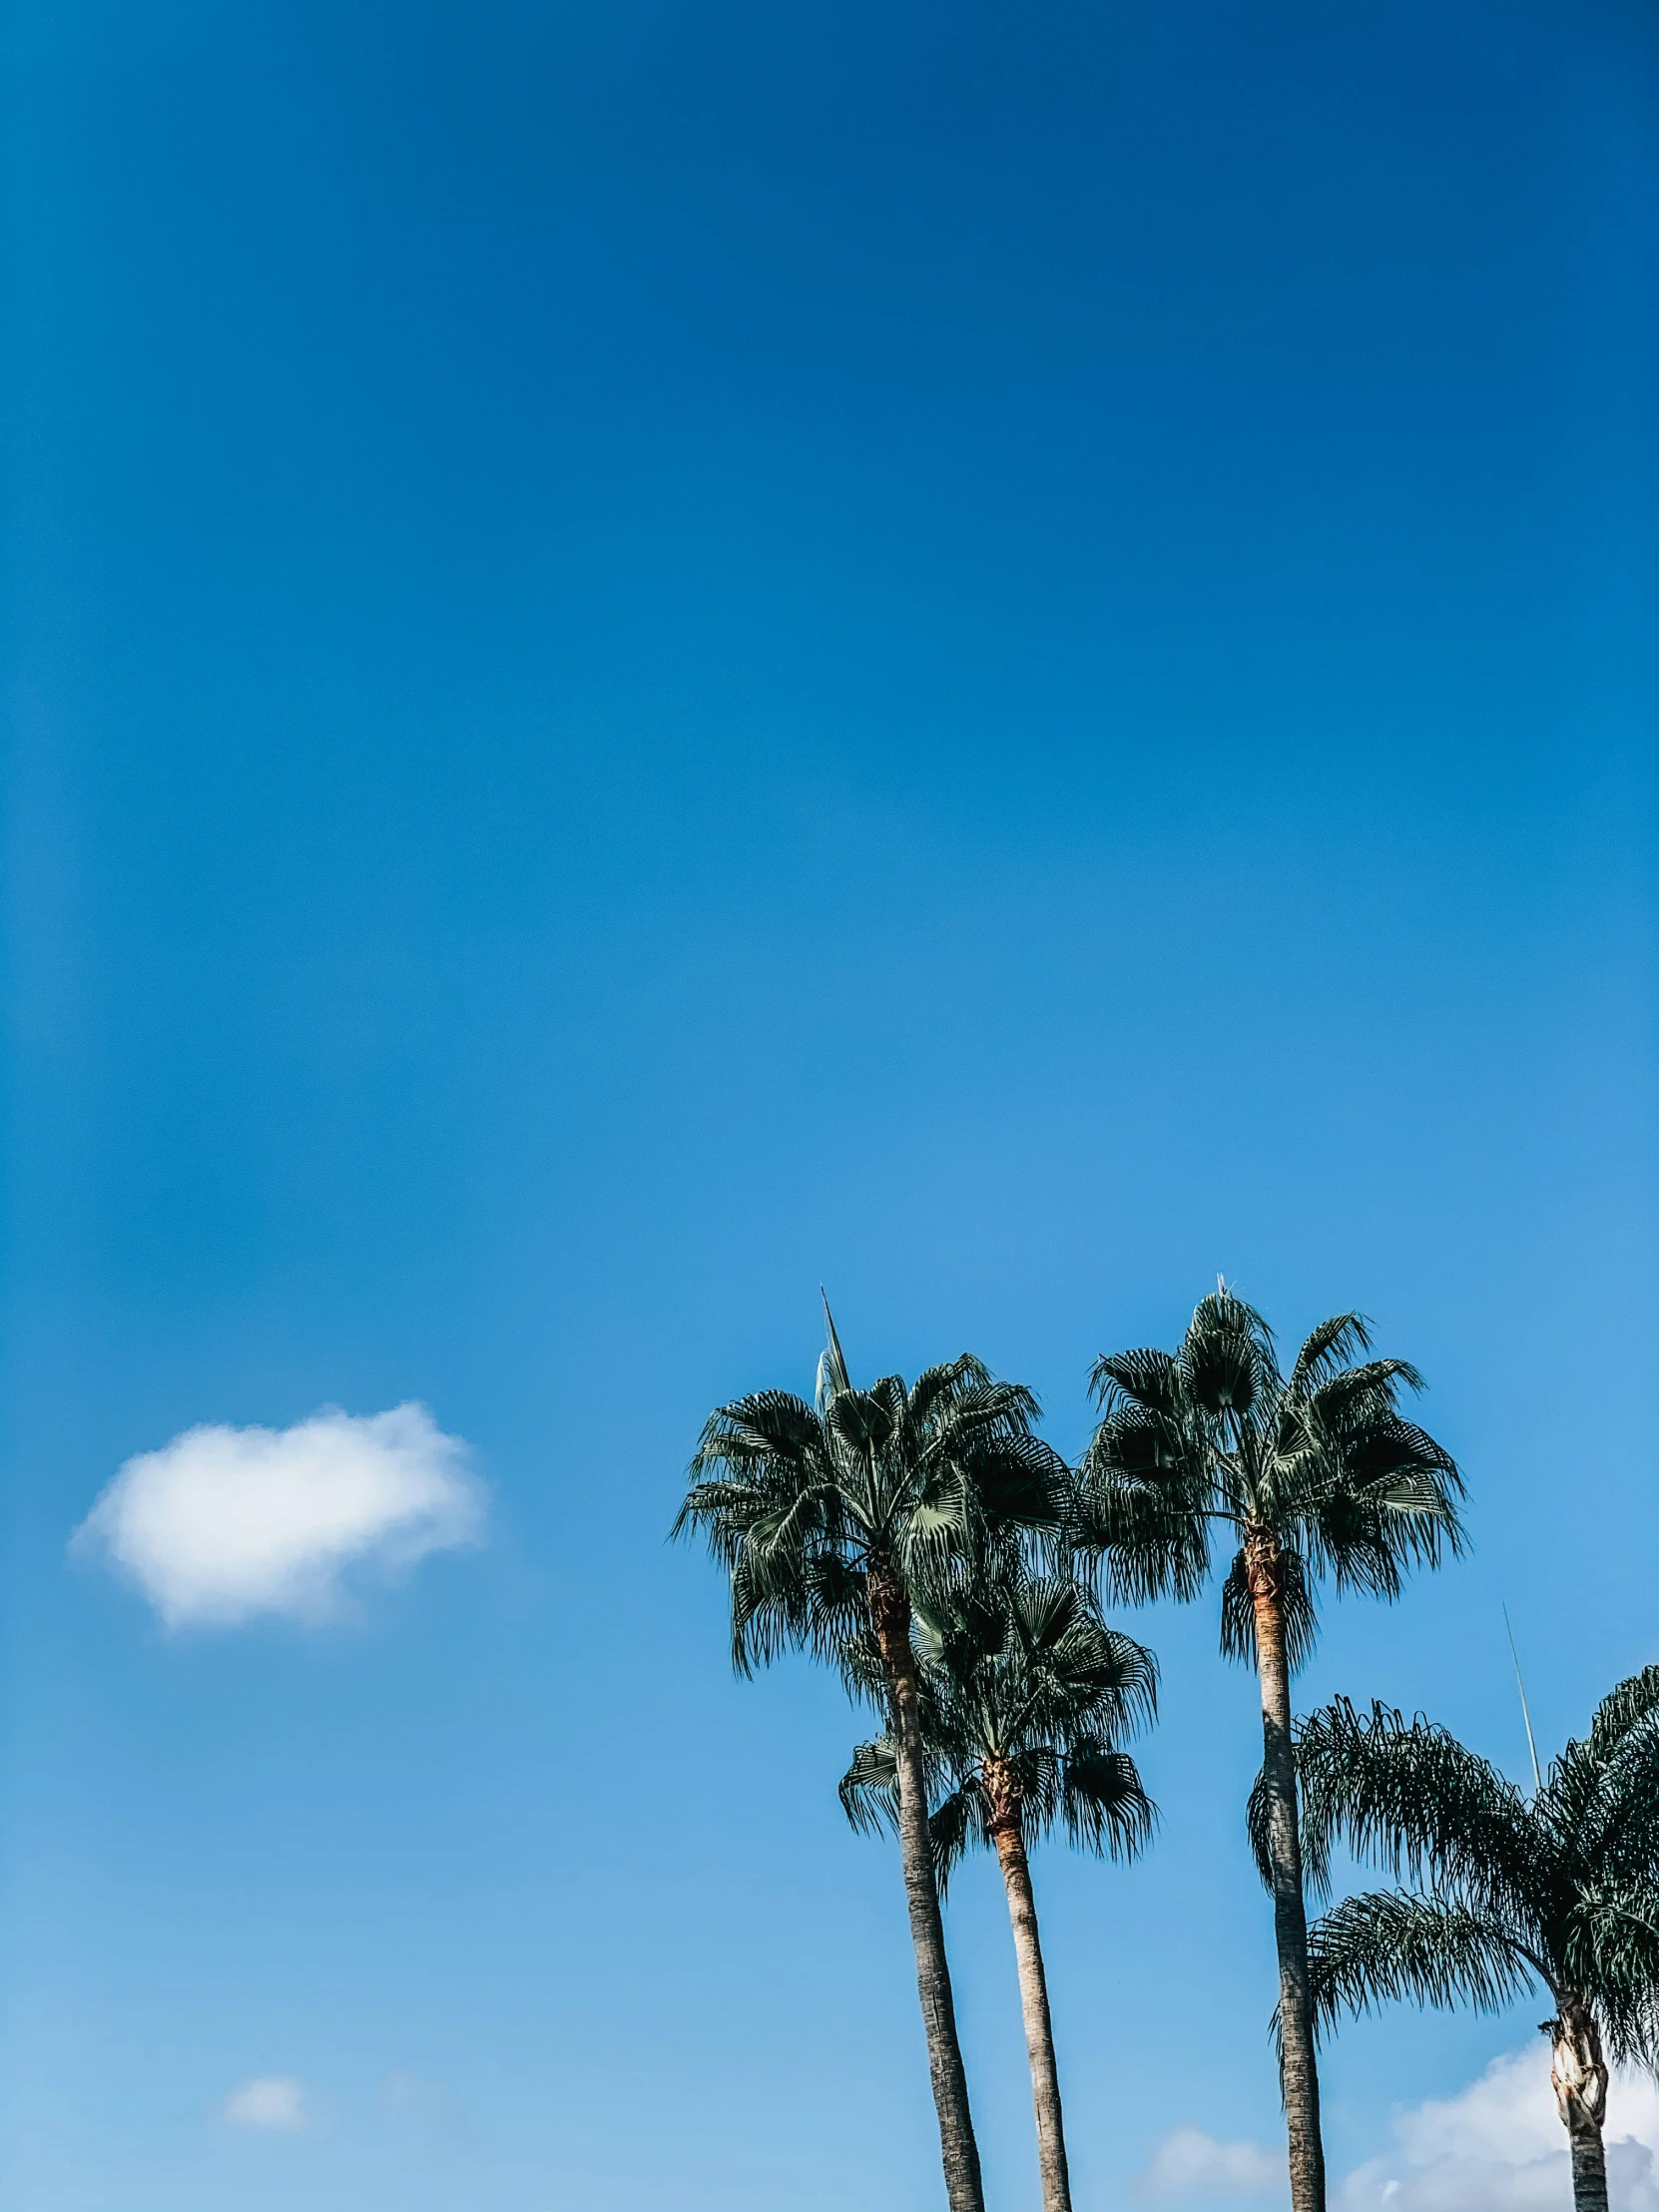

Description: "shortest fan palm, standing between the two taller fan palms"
840 1577 1157 2212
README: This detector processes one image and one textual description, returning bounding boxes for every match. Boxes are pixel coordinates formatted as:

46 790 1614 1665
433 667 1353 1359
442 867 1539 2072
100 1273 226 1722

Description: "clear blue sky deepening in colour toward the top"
2 0 1659 2212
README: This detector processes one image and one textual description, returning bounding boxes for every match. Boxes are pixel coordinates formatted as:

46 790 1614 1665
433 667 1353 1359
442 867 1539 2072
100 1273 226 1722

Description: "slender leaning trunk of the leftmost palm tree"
867 1568 984 2212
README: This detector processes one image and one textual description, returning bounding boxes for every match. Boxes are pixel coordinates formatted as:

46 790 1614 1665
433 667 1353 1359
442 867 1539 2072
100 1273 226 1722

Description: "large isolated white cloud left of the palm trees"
71 1402 484 1628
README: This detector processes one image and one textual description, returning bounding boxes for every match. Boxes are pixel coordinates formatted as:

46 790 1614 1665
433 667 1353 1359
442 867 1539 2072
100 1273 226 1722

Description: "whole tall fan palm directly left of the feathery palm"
1075 1283 1462 2212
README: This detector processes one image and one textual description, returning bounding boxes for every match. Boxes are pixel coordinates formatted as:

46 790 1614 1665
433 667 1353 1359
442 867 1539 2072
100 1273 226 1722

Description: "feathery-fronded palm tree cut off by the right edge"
1297 1666 1659 2212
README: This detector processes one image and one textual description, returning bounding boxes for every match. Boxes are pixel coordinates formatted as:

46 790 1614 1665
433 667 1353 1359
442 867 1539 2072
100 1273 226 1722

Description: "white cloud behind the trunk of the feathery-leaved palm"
1336 2035 1659 2212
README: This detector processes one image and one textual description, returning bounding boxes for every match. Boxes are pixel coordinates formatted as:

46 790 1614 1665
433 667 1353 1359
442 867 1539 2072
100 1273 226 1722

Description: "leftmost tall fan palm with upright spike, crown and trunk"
675 1308 1066 2212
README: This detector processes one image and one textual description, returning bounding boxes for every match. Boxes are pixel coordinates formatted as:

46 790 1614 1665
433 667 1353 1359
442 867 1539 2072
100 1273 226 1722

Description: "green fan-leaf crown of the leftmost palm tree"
673 1323 1066 1672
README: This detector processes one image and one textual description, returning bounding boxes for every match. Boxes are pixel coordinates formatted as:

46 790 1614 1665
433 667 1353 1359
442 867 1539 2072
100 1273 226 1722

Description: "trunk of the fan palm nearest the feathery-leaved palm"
1246 1533 1325 2212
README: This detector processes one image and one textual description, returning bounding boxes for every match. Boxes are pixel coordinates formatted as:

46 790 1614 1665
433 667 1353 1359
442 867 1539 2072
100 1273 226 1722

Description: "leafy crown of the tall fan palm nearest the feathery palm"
1073 1285 1462 1666
